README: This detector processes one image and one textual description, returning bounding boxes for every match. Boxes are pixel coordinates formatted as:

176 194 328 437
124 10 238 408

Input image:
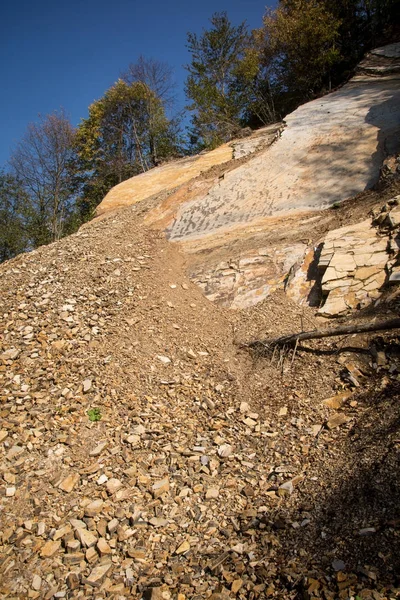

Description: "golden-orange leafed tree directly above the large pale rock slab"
262 0 340 110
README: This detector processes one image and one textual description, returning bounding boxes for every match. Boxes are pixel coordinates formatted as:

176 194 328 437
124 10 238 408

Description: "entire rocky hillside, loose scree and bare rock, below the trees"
0 45 400 600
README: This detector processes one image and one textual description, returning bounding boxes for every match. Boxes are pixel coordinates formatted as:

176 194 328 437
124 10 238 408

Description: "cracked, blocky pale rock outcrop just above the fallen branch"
287 196 400 317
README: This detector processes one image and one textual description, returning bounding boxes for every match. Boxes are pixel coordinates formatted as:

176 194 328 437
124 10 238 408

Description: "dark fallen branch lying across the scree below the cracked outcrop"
243 319 400 349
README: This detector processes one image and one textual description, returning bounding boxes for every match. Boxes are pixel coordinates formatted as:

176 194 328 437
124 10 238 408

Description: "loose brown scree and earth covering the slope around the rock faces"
0 176 400 600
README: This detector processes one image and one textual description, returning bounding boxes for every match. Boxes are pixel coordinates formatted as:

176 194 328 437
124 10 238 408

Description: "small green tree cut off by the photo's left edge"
0 172 29 262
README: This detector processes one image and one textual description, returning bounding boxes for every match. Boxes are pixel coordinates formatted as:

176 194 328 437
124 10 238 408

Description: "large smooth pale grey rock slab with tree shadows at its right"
167 77 400 242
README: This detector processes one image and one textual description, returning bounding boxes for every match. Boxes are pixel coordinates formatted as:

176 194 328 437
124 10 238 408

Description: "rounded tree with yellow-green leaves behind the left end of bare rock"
77 79 177 209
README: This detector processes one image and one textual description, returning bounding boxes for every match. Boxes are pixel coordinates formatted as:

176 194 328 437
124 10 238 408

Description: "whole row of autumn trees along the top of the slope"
0 0 400 261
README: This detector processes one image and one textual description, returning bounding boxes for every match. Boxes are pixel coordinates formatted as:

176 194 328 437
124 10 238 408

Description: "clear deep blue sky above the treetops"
0 0 275 167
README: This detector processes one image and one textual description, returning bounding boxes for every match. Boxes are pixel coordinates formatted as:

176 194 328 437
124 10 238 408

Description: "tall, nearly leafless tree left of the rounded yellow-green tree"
9 110 76 247
